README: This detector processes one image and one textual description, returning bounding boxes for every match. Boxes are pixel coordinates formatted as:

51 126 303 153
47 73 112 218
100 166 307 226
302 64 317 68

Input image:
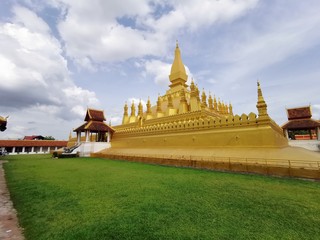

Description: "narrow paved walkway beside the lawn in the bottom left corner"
0 160 24 240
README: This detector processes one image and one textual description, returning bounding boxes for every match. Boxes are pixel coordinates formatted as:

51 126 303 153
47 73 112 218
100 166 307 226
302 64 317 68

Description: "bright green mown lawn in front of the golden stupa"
4 155 320 240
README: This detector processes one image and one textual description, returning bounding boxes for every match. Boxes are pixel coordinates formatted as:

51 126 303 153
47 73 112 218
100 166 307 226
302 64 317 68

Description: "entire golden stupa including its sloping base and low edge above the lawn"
86 44 320 178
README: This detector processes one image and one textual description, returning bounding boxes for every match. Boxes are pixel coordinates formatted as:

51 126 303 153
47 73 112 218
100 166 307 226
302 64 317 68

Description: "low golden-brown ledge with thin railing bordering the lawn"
93 153 320 179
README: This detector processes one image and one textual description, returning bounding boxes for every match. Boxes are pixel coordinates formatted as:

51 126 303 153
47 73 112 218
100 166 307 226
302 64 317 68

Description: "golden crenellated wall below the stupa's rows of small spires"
112 113 288 148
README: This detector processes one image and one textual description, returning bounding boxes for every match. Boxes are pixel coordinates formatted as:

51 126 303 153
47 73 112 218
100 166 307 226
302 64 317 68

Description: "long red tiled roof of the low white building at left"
0 140 68 147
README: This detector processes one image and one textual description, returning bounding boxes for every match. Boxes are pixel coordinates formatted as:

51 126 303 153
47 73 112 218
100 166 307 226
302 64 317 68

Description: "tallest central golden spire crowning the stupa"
169 42 188 90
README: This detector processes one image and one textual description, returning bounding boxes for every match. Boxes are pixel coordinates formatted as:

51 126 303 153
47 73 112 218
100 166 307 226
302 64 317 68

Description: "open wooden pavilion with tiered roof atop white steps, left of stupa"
73 108 114 144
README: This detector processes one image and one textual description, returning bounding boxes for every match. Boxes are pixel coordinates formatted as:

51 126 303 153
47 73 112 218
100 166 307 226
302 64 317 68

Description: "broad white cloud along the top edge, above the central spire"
40 0 258 69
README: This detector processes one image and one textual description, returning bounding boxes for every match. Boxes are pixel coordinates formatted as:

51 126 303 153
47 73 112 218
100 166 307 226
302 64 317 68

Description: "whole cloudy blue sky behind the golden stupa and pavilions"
0 0 320 139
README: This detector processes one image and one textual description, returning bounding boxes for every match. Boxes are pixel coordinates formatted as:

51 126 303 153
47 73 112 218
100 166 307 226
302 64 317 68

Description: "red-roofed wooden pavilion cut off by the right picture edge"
282 106 320 140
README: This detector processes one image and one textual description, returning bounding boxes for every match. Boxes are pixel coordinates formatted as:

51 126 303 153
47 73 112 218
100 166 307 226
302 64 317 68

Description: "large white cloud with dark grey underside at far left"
0 6 99 119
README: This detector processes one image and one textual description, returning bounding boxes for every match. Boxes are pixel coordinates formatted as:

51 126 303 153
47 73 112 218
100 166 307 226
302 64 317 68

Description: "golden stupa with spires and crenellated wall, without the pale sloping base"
105 43 288 151
